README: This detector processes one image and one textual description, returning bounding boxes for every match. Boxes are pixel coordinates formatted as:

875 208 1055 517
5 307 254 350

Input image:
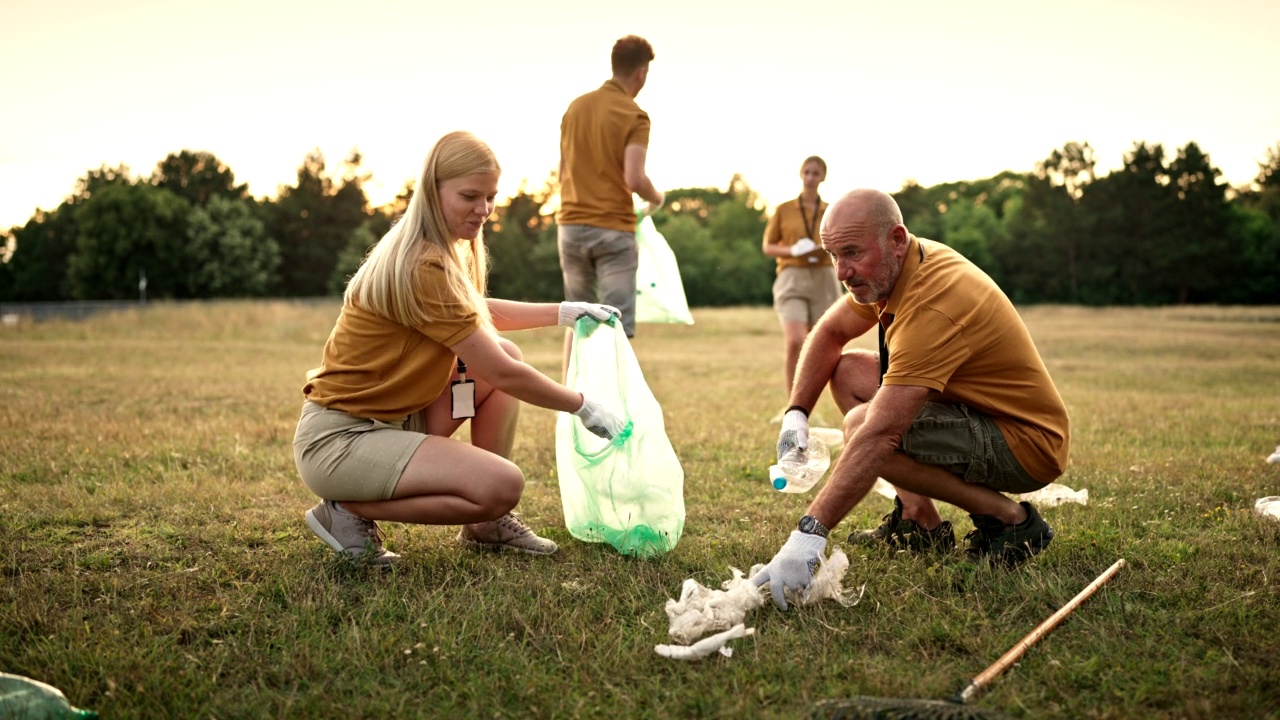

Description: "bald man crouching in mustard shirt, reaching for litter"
753 190 1070 610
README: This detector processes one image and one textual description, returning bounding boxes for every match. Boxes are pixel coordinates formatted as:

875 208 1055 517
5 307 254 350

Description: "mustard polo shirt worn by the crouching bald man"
846 236 1070 483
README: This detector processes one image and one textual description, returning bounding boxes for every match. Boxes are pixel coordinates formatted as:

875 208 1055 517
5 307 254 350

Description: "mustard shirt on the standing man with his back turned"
556 79 649 232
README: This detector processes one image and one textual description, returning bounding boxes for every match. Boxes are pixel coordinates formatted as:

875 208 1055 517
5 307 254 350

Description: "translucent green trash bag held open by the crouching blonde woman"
556 316 685 557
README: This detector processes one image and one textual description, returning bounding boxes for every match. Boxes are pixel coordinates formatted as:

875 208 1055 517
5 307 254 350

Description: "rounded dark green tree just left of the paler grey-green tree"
67 183 191 300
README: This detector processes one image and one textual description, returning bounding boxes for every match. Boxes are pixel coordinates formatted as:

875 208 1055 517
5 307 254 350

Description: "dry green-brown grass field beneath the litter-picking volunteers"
0 302 1280 720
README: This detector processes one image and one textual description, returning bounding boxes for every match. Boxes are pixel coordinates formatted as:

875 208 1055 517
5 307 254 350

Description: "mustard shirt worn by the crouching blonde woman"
302 243 480 421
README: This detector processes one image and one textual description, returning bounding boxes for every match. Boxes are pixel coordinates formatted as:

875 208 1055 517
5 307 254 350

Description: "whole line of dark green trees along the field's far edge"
0 142 1280 306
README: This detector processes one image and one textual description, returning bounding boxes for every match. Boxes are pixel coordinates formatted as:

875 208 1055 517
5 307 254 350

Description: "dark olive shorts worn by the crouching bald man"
900 402 1047 493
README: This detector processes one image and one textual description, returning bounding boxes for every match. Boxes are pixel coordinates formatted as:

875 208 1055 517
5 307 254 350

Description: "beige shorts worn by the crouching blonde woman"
293 400 426 501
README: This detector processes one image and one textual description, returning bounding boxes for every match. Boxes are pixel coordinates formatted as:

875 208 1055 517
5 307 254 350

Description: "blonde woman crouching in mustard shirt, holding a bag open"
293 132 622 565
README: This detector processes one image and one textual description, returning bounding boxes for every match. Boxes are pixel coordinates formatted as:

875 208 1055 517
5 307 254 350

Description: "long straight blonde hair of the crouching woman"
343 132 502 325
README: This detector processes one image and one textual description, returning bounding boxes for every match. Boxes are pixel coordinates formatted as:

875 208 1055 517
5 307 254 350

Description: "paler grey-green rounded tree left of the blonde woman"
183 195 280 297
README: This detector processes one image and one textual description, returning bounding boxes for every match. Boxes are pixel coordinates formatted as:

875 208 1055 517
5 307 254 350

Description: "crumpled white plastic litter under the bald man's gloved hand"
654 548 867 660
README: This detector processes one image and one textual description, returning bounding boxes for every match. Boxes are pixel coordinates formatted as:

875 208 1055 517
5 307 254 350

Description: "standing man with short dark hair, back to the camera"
556 35 663 368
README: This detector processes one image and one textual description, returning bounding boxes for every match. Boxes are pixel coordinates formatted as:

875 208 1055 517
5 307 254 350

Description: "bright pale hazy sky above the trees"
0 0 1280 231
